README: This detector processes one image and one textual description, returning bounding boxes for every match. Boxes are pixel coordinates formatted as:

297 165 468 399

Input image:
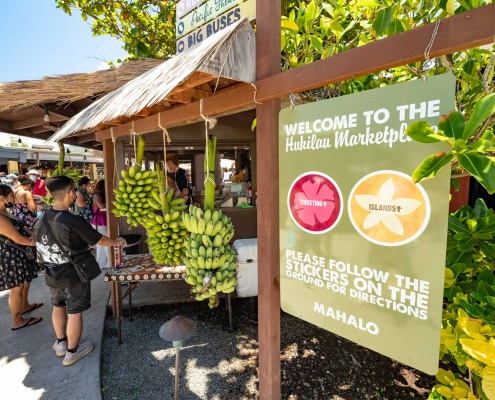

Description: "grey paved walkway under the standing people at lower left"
0 272 110 400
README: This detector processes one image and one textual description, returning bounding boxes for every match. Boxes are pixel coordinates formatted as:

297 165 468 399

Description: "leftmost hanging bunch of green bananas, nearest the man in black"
112 135 158 226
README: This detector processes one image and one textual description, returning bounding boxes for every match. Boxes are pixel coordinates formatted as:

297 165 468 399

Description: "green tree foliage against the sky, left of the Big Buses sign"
55 0 175 59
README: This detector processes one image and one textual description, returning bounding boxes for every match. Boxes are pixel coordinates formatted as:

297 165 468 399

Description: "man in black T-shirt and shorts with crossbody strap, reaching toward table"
34 176 125 366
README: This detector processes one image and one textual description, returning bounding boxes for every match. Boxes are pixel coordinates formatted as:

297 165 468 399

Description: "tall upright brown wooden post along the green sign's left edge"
256 0 281 400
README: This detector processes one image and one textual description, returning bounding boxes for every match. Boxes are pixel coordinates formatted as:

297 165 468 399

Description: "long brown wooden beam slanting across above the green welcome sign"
97 2 495 140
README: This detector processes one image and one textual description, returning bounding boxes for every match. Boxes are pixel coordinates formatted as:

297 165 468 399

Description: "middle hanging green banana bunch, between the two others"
144 164 189 266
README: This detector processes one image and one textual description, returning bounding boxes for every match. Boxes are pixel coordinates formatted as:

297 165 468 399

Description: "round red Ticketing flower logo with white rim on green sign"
287 172 342 234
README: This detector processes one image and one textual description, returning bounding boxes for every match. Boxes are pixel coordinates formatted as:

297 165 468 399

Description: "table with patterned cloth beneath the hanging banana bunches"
103 254 233 344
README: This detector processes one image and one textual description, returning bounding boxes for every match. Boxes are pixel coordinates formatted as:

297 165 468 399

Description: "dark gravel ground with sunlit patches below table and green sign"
101 298 435 400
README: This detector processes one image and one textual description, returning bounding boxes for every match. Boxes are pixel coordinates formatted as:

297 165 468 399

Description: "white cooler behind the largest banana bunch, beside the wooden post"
232 238 258 297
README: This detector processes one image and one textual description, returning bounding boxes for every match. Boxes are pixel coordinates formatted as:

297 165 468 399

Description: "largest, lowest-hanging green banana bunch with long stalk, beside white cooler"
182 136 237 308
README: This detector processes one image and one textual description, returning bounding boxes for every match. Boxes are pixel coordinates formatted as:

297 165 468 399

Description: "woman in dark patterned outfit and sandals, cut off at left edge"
0 185 43 330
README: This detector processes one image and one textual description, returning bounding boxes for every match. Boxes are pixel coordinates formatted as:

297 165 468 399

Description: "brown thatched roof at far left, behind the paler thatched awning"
0 59 163 113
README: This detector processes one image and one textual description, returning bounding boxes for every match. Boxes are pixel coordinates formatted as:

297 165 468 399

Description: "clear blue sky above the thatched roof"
0 0 126 82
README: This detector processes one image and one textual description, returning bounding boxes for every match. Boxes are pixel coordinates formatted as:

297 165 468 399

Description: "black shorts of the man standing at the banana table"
50 282 91 314
